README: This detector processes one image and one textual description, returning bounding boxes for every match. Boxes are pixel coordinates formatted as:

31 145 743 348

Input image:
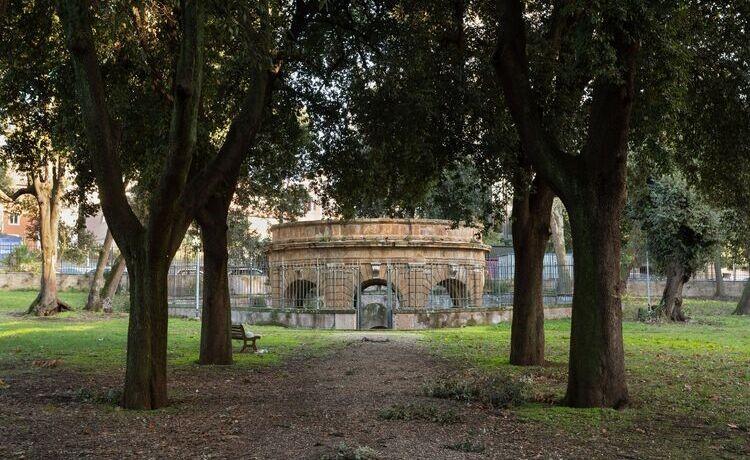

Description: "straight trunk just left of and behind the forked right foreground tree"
510 179 554 366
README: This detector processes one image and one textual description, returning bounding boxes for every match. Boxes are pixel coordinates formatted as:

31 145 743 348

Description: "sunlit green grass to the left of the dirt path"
0 291 331 371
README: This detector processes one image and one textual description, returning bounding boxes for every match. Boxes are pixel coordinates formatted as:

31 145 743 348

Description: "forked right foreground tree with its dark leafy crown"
489 0 704 407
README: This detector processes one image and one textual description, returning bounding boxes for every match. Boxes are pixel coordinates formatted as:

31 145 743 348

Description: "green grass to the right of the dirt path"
422 299 750 458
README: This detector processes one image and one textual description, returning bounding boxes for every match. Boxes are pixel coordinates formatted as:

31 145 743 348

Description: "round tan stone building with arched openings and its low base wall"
247 219 508 329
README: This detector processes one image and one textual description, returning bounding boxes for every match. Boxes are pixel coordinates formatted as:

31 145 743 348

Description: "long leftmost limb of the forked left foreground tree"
59 0 143 251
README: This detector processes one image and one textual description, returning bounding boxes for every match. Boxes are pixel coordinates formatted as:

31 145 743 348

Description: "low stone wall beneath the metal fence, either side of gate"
169 305 571 330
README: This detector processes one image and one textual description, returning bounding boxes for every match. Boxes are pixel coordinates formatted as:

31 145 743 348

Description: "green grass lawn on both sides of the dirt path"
0 291 750 458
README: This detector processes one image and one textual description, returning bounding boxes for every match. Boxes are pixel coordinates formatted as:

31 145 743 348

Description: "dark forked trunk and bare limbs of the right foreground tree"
494 0 638 407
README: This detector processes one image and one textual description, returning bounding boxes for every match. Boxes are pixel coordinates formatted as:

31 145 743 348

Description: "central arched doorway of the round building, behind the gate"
354 278 401 329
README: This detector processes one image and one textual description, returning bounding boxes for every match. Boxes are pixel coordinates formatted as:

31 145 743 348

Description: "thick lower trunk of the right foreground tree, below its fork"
565 185 628 407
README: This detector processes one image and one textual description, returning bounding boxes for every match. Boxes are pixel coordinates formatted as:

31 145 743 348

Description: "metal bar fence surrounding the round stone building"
169 254 574 311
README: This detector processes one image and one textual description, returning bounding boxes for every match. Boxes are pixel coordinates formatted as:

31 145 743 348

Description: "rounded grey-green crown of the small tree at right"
629 176 720 277
